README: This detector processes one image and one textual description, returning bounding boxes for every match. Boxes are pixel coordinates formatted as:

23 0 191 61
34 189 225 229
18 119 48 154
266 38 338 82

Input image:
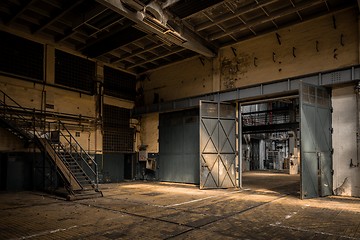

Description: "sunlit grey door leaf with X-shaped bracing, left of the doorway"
200 101 237 189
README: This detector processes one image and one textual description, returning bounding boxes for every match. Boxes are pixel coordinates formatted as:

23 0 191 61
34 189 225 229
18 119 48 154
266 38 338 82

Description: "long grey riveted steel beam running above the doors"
133 65 360 115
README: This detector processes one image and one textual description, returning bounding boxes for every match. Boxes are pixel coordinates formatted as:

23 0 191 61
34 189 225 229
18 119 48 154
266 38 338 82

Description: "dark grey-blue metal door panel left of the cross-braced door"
158 109 199 184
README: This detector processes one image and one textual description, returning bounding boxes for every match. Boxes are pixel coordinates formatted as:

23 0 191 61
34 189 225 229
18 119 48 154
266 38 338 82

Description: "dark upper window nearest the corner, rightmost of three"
104 66 136 101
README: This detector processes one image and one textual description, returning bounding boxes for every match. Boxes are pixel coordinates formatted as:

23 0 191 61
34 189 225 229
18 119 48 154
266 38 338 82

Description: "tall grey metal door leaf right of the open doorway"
300 83 332 199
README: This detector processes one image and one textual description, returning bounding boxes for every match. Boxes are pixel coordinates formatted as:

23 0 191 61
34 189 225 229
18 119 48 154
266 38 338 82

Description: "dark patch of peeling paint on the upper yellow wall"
220 51 251 89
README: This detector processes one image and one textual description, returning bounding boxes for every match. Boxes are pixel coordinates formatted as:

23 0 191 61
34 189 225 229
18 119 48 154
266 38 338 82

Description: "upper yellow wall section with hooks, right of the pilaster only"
217 8 359 90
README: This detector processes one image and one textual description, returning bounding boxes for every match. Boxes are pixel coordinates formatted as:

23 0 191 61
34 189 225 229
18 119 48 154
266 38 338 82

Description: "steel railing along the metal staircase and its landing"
0 90 99 193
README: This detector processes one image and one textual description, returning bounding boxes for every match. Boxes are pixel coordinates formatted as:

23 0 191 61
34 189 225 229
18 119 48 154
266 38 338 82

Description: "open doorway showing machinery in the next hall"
240 96 300 197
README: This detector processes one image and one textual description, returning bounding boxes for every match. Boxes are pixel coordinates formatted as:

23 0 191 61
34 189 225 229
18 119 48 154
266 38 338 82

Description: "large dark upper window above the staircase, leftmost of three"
0 31 44 81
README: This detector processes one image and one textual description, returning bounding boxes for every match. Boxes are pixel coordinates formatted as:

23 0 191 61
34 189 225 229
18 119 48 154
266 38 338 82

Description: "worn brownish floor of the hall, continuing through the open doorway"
0 172 360 239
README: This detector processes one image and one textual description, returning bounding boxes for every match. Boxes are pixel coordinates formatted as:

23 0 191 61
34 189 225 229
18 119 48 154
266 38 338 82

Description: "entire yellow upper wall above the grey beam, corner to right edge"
143 8 359 101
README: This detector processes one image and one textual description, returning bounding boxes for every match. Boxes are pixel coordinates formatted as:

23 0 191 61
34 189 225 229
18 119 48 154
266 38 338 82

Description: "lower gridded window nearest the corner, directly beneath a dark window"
103 105 134 152
